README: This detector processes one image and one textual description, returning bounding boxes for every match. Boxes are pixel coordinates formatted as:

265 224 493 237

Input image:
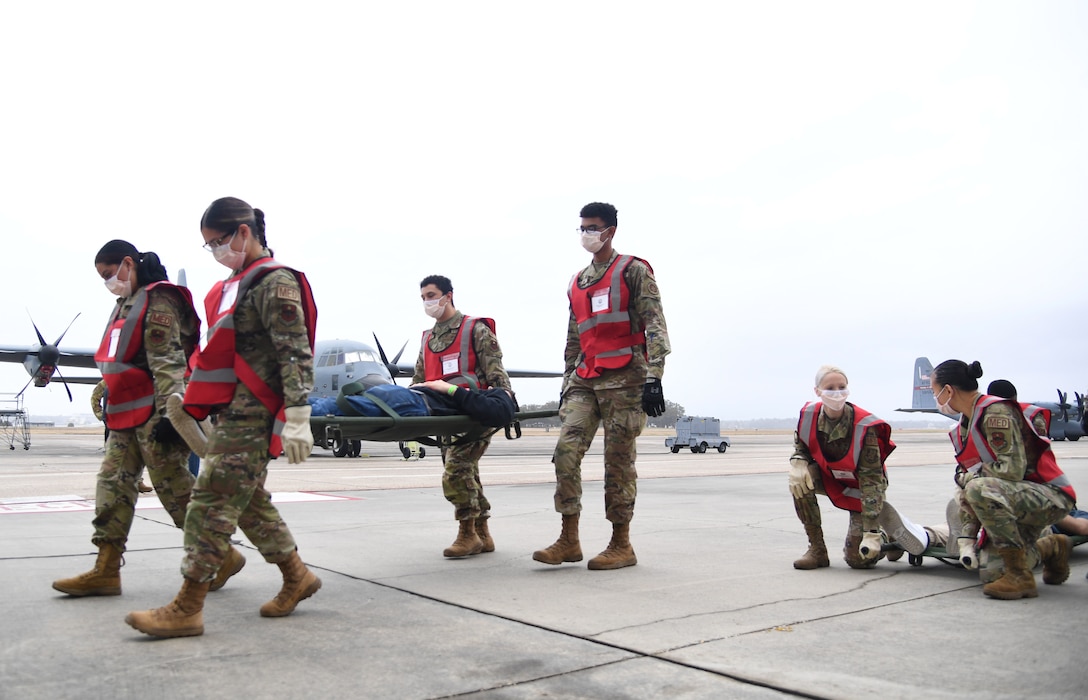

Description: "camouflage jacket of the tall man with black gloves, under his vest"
562 250 672 389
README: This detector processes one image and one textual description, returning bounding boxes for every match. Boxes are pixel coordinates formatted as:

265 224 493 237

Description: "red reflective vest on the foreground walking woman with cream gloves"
184 258 318 457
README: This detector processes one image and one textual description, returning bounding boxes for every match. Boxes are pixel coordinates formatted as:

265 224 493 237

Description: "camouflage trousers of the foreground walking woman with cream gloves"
182 418 296 582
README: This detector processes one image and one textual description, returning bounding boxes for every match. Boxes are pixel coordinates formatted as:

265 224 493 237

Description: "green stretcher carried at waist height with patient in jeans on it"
310 409 559 450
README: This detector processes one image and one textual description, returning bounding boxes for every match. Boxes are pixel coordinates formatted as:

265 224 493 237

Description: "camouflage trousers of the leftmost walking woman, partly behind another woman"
90 416 193 552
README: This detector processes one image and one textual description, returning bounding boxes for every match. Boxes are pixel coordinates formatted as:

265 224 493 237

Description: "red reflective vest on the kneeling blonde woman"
798 401 895 513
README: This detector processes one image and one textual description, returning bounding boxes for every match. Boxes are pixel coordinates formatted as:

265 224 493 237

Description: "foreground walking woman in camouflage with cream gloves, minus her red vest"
125 197 321 637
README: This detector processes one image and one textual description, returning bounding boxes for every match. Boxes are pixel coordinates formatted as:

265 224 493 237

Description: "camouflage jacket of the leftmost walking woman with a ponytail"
110 285 200 415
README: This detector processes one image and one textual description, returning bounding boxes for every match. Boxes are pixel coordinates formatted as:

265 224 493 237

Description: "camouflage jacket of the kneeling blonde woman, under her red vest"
793 404 888 530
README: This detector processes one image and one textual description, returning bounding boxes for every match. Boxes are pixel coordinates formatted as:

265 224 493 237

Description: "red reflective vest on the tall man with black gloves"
567 255 653 379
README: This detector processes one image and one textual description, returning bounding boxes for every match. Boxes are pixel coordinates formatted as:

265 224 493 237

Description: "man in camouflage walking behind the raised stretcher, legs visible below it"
412 275 511 557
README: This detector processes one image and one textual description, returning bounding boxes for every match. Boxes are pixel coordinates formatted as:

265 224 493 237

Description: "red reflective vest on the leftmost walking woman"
95 282 199 430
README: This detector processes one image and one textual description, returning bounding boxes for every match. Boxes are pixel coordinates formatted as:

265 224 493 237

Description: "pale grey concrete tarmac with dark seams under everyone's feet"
0 430 1088 700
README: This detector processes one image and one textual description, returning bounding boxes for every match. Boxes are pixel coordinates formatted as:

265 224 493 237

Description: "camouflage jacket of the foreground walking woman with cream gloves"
226 251 313 416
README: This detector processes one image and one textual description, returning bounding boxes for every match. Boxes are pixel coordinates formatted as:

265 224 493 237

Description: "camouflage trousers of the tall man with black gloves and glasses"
552 377 646 525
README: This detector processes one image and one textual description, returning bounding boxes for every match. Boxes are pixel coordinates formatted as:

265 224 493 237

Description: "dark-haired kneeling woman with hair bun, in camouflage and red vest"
930 360 1076 600
